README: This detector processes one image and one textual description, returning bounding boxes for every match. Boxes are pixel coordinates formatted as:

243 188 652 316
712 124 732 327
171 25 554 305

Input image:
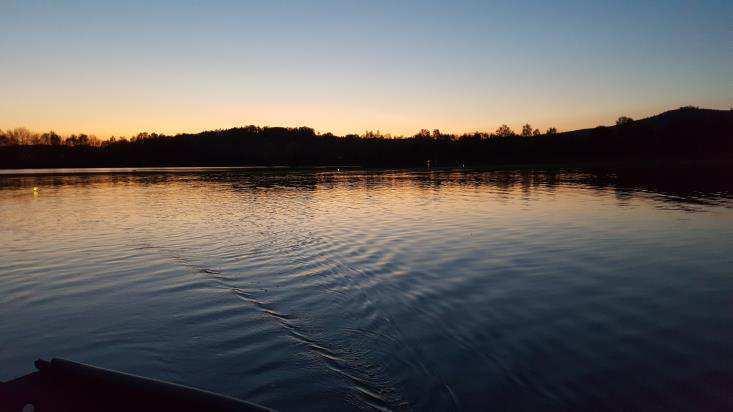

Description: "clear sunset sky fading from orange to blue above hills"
0 0 733 137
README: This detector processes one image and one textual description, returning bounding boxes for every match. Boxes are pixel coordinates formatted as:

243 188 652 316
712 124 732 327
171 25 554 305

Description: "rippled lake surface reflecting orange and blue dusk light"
0 169 733 410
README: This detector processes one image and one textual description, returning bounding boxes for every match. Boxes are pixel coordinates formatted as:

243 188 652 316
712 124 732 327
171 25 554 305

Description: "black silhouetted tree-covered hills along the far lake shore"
0 107 733 168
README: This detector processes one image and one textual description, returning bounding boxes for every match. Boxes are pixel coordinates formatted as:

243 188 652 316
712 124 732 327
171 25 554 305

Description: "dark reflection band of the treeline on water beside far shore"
0 167 733 211
